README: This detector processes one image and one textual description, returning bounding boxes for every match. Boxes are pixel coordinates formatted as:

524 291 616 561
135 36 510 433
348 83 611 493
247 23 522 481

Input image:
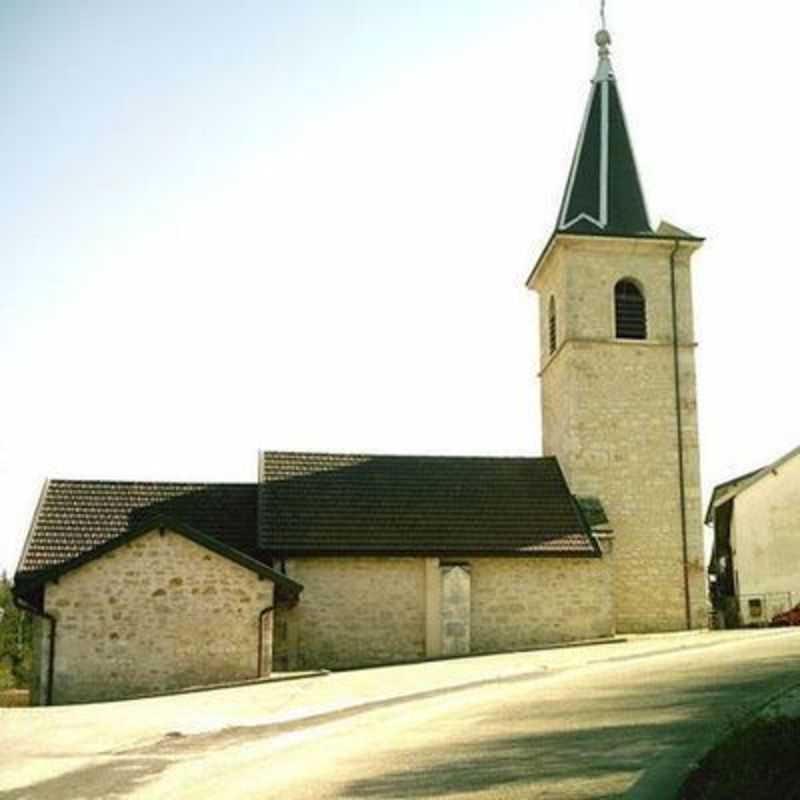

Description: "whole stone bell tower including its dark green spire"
528 30 707 632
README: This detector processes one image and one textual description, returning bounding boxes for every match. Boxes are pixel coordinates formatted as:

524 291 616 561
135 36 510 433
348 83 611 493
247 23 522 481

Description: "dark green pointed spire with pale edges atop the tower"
556 29 652 236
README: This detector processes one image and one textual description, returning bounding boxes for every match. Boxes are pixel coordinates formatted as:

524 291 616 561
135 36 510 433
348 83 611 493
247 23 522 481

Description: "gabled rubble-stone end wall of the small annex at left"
45 531 273 704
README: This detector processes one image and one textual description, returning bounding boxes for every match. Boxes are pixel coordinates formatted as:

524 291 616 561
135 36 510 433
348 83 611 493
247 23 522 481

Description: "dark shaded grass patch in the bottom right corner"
678 716 800 800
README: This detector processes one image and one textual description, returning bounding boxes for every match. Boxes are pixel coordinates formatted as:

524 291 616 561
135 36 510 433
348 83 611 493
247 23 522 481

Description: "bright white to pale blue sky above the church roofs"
0 0 800 572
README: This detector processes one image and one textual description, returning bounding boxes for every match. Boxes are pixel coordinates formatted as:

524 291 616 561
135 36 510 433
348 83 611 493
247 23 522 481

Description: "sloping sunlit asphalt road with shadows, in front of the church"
0 632 800 800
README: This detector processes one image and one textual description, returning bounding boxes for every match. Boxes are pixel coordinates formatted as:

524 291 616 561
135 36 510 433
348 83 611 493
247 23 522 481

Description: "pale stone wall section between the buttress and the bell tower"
470 557 614 653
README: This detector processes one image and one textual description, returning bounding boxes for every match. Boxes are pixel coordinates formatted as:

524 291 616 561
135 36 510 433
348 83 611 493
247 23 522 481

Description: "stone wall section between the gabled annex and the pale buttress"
275 557 425 669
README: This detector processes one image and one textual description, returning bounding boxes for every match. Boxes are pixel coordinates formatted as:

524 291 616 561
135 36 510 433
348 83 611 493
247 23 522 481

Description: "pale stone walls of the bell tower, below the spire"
531 235 707 632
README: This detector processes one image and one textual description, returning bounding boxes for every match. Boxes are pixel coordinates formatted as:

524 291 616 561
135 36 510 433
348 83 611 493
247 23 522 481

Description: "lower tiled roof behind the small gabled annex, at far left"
17 480 258 576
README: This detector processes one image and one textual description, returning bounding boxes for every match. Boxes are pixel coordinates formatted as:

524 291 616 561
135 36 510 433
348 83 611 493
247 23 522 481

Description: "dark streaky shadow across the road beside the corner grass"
342 658 800 800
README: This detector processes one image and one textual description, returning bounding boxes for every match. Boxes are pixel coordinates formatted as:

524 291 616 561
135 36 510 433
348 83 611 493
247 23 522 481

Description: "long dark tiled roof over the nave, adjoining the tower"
259 453 599 556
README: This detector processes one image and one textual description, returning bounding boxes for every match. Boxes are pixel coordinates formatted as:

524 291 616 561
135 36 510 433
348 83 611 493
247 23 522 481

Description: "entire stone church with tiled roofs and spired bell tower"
14 25 707 704
